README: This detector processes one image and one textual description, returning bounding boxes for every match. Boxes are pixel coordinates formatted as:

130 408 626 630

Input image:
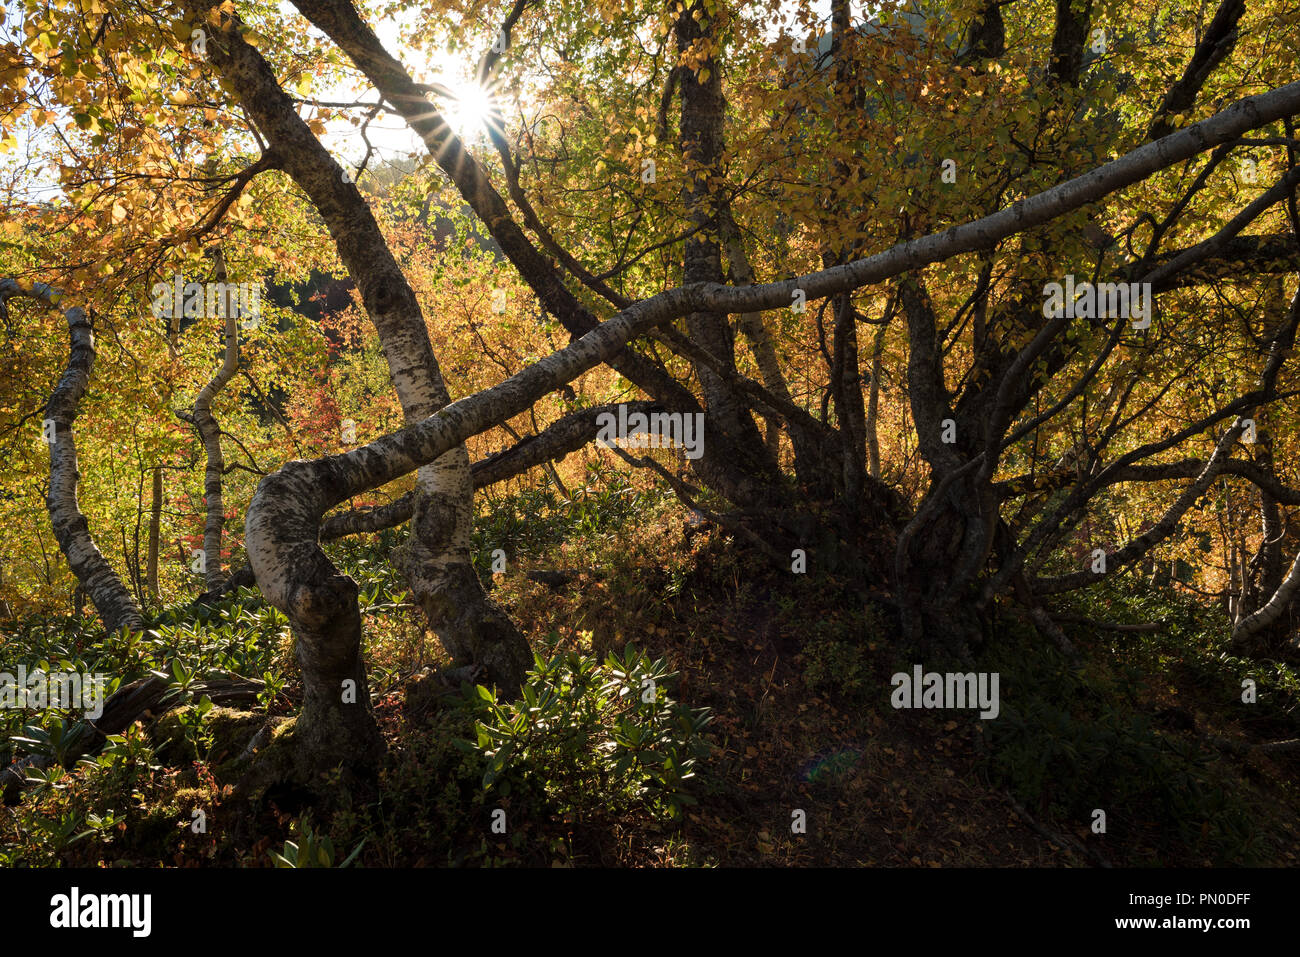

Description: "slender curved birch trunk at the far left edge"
0 280 144 632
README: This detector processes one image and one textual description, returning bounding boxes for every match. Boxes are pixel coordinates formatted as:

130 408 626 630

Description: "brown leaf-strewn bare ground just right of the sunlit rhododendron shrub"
491 538 1060 867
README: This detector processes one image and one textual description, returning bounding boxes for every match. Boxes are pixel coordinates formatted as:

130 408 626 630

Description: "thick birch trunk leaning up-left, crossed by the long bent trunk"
194 3 533 702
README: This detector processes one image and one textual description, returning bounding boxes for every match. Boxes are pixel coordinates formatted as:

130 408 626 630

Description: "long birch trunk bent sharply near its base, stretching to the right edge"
228 70 1300 767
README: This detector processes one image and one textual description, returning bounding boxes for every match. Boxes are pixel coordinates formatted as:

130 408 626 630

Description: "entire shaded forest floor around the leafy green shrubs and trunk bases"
0 488 1300 867
